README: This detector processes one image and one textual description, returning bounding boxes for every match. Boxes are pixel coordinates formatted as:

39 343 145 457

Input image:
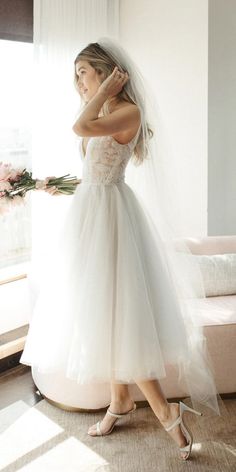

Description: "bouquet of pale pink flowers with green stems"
0 162 81 214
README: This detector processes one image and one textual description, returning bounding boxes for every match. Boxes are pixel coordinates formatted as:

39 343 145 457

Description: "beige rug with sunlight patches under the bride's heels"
0 399 236 472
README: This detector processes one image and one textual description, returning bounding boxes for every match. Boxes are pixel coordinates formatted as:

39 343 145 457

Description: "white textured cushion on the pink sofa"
195 253 236 297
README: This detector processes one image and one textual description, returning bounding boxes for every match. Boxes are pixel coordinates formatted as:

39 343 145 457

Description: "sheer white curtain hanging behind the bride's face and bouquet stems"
30 0 119 302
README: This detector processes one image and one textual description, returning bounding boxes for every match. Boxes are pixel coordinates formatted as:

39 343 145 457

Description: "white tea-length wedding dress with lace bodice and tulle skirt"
20 127 192 384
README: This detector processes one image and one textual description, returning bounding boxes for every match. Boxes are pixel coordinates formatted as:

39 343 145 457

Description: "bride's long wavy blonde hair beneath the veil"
74 43 153 165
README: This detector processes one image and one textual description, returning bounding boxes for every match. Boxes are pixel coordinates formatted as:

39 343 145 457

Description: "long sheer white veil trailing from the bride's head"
97 37 223 414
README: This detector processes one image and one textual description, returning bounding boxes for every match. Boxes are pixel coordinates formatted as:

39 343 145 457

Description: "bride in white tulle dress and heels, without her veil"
21 38 220 460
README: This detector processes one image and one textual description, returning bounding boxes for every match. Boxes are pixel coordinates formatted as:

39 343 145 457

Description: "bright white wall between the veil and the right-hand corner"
120 0 208 236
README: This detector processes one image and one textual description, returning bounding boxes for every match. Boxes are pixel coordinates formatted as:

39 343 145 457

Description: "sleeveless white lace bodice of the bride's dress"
80 127 140 185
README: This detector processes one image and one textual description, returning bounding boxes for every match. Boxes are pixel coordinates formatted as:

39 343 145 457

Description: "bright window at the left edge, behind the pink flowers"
0 40 33 272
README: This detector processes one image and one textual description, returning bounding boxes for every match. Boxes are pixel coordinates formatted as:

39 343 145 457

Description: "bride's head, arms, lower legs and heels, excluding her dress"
73 45 205 459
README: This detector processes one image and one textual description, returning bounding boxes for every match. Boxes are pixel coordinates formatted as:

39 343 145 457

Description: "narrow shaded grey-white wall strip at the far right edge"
208 0 236 235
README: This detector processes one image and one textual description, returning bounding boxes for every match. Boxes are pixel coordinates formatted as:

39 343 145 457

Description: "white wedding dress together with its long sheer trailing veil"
20 34 225 414
